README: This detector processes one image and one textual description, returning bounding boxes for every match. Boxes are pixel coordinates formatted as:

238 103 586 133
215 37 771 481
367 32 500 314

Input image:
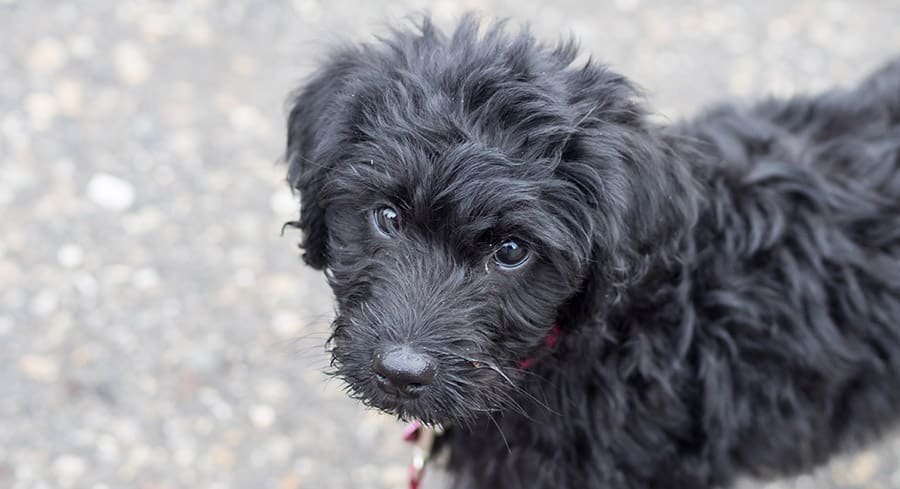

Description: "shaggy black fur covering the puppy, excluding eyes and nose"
287 19 900 489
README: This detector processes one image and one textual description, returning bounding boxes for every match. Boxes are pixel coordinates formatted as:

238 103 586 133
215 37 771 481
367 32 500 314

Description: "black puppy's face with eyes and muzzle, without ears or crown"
316 126 587 421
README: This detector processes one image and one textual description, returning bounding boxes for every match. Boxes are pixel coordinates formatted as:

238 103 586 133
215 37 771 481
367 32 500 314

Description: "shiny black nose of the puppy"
372 346 437 397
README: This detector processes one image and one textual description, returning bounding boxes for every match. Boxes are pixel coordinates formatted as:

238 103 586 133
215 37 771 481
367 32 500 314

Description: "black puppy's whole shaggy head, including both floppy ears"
287 19 691 422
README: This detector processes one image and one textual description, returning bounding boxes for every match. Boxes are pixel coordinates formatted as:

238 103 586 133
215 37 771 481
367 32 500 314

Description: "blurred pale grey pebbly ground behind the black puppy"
0 0 900 489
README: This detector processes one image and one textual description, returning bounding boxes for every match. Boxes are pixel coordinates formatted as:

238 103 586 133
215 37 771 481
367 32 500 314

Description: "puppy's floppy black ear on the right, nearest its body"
560 64 700 315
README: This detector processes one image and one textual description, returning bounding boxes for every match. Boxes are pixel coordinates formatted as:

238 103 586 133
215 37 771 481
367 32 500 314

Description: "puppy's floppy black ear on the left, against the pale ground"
285 53 355 269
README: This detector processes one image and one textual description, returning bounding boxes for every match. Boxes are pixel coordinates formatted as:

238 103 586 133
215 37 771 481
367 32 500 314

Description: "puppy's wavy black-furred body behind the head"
450 58 900 489
